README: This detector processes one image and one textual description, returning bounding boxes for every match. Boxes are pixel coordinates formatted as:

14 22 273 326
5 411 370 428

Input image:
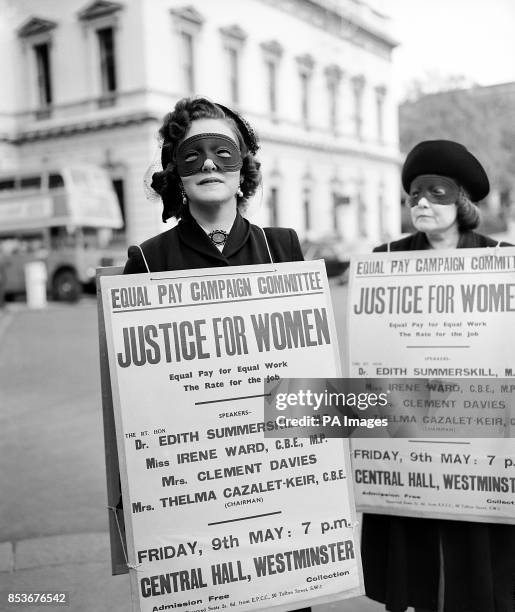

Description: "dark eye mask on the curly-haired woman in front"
176 134 243 176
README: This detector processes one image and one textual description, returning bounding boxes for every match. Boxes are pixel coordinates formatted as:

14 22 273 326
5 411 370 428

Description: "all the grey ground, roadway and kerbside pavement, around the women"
0 286 392 612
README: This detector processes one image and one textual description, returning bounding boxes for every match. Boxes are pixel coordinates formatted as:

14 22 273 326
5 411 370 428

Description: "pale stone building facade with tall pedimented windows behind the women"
0 0 400 246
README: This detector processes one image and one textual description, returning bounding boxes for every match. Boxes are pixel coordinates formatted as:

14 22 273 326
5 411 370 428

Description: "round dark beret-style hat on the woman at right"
402 140 490 202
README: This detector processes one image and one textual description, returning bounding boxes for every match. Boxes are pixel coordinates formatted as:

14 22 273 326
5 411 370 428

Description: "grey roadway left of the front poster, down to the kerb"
0 300 106 542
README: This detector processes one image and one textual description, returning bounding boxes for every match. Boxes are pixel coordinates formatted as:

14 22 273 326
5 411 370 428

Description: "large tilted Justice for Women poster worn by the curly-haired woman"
101 261 363 612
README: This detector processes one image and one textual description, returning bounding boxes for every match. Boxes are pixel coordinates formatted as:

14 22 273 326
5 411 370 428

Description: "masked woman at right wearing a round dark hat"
362 140 515 612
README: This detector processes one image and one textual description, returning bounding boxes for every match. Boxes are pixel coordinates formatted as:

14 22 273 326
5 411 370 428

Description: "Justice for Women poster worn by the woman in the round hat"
348 247 515 523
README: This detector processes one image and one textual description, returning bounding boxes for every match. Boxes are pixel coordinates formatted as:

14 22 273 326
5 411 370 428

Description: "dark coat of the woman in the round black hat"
362 232 515 612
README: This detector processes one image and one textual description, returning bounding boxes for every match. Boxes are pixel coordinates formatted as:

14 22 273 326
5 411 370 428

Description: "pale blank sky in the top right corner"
380 0 515 93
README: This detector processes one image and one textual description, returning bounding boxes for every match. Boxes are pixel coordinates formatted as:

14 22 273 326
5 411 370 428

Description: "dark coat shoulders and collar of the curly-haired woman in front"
124 209 304 274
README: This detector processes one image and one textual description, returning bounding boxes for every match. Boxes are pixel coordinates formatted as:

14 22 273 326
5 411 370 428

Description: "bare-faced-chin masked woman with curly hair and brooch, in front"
124 98 311 612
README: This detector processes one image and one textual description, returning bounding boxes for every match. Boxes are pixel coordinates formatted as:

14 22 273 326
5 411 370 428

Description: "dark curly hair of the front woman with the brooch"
151 98 261 222
